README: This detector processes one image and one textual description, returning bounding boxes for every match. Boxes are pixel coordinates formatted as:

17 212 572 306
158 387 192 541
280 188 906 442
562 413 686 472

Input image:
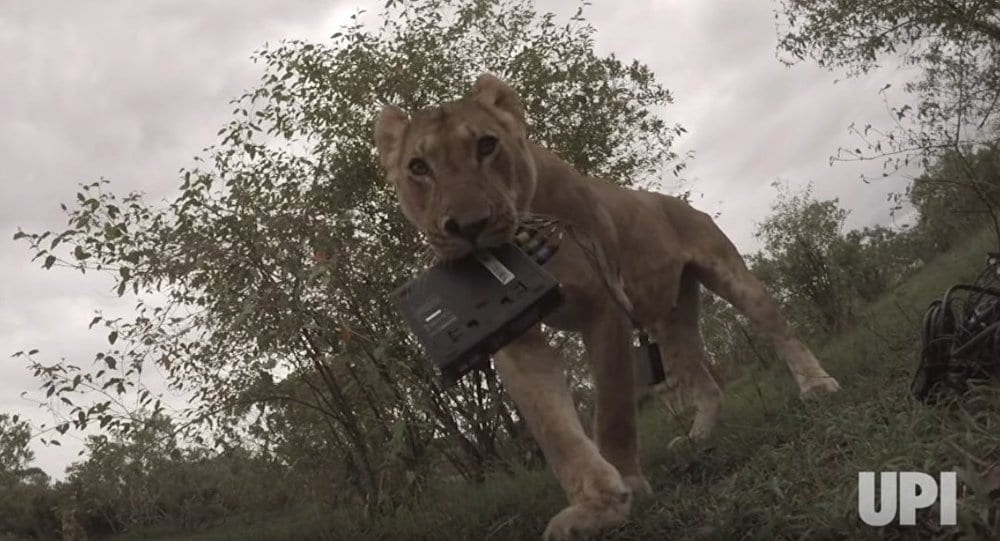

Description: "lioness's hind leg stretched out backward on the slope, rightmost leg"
695 240 840 398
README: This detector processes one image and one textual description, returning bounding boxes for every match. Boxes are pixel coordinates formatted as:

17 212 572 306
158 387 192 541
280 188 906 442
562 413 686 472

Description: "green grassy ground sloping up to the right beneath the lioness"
111 230 1000 540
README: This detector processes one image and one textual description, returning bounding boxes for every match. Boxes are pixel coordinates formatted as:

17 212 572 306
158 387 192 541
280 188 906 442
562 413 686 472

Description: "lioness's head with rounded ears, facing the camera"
375 74 537 260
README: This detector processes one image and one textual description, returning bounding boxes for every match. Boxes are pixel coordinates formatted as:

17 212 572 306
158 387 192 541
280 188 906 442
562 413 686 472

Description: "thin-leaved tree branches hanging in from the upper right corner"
778 0 1000 245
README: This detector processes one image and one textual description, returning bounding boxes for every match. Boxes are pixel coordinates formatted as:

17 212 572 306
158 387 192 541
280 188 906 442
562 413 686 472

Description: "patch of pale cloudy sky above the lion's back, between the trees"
580 0 907 249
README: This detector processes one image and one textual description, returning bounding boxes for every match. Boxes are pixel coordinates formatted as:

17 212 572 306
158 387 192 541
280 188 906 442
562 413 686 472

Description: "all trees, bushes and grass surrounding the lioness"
0 0 1000 539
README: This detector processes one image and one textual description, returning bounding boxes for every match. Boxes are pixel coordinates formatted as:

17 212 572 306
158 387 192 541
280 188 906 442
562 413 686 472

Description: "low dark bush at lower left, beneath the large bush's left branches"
57 416 294 535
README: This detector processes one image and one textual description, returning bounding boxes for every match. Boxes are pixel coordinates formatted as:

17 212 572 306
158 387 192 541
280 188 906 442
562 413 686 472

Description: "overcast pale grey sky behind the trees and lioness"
0 0 906 477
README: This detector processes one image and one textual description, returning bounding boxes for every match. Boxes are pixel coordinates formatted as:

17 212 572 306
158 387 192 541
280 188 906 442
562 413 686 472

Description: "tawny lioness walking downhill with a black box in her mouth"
374 74 840 539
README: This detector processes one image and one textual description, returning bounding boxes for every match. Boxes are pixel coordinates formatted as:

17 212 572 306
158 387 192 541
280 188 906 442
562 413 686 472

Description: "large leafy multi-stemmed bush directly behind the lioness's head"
15 0 683 509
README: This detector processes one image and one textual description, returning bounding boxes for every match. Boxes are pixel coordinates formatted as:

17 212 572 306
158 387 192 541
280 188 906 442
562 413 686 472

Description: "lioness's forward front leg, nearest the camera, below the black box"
496 327 631 539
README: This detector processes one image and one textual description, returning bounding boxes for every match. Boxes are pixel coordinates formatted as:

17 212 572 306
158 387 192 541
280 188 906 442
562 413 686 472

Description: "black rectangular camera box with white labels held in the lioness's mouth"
393 224 562 385
